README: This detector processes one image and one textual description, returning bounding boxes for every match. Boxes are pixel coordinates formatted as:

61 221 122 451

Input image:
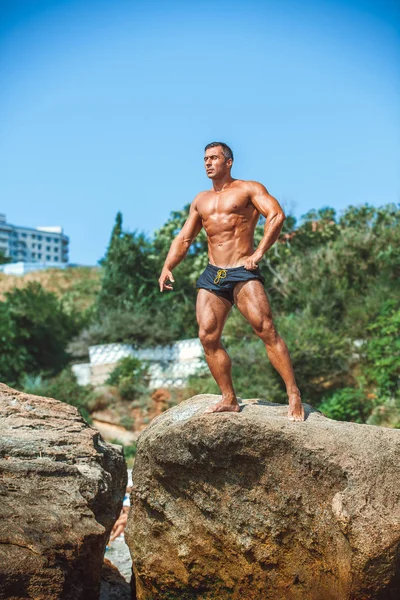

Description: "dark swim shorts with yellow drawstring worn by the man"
196 263 265 304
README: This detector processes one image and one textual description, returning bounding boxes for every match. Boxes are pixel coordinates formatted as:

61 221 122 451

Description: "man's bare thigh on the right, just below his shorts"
233 279 272 328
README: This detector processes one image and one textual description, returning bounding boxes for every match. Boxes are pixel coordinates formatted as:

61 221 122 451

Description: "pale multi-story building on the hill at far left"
0 214 69 264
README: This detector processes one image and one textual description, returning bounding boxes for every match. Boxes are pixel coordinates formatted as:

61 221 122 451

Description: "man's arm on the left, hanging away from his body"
158 197 203 292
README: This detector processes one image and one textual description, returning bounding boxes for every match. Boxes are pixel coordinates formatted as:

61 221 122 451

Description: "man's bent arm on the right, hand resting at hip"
244 181 286 271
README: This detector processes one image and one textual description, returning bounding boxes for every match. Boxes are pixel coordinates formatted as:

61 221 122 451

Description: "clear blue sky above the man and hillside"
0 0 400 264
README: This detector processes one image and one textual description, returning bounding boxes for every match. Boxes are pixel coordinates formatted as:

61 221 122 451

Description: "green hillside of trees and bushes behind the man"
0 205 400 427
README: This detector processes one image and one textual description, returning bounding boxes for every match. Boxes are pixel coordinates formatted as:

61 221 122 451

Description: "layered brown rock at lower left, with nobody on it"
0 384 127 600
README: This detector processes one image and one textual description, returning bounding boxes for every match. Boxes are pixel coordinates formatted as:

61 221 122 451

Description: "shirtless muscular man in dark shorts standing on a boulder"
159 142 304 421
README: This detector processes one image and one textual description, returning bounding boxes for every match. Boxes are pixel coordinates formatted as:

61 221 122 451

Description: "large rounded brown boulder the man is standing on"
126 395 400 600
